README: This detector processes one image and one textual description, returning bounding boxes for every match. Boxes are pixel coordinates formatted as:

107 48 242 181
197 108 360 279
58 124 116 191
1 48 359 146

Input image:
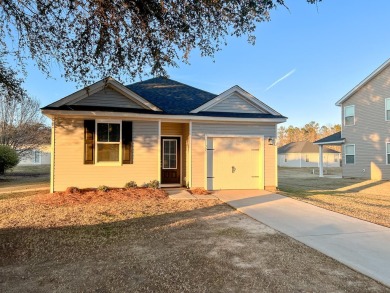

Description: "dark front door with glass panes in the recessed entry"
161 137 180 184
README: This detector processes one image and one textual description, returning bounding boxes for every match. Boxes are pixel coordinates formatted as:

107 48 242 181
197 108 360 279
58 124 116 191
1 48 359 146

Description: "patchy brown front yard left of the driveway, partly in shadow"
0 189 388 292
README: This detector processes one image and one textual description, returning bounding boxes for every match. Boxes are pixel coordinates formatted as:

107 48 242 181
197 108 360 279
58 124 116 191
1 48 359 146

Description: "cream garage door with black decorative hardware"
207 137 260 190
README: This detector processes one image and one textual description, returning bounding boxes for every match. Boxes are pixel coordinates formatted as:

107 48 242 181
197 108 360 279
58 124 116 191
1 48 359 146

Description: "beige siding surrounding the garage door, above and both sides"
192 122 277 188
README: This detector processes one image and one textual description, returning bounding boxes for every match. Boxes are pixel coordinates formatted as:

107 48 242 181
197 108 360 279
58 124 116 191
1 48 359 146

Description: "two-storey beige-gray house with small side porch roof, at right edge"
315 59 390 180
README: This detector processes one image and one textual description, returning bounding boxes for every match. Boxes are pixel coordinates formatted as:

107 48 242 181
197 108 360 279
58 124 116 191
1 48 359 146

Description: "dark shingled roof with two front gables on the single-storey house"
42 77 286 119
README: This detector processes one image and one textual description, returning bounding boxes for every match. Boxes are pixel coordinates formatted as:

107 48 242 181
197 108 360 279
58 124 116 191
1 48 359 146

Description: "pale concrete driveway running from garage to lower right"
214 190 390 286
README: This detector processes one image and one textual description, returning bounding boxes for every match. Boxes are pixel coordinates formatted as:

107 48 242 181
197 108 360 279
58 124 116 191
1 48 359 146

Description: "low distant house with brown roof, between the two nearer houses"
278 141 341 168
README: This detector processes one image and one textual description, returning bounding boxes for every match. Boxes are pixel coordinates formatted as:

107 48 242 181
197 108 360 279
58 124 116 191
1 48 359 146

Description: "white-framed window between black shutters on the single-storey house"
96 122 121 162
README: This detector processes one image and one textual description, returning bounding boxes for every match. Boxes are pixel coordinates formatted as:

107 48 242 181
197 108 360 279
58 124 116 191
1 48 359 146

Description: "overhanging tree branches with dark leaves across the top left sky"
0 0 321 98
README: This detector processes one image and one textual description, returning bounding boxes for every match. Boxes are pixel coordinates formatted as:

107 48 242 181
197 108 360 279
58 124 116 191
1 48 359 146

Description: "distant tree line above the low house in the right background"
277 121 341 147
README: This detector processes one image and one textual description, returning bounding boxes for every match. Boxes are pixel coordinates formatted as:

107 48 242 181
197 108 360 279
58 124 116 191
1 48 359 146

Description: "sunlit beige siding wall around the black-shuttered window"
54 119 160 191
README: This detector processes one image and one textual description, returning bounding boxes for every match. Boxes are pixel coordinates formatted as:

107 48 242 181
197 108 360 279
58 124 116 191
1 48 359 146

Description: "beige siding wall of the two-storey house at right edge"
341 67 390 180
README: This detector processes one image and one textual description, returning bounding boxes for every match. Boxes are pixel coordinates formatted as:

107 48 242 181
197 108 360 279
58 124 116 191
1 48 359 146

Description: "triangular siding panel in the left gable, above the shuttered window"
74 88 143 109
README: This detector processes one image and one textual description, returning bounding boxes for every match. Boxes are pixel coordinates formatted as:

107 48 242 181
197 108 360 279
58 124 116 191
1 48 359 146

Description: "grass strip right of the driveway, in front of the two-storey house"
279 168 390 227
